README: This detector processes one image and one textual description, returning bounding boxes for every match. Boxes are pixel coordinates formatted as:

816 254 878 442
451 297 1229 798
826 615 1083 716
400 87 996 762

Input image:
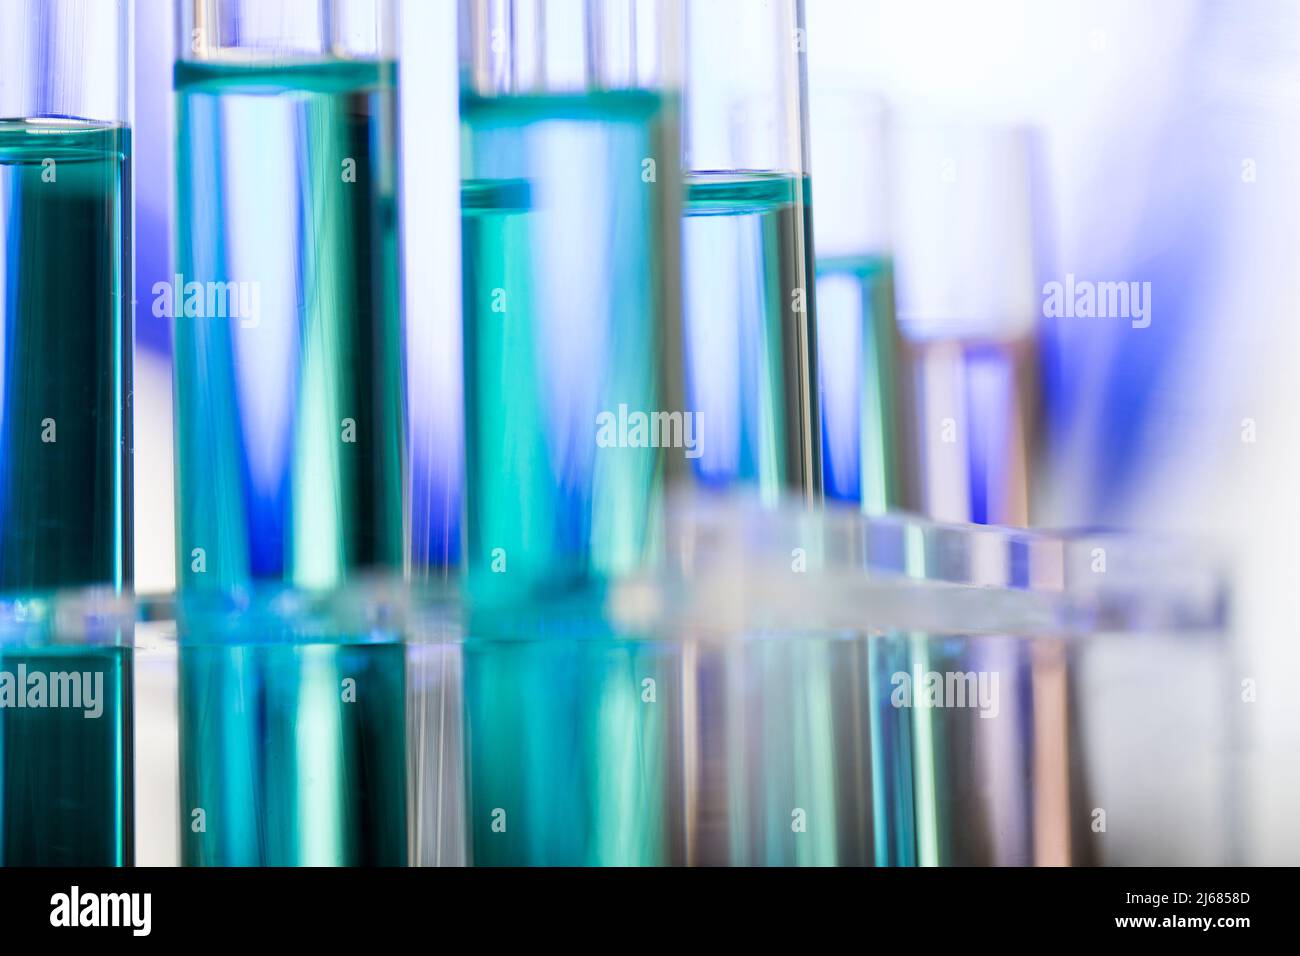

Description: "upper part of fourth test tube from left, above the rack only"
683 0 822 501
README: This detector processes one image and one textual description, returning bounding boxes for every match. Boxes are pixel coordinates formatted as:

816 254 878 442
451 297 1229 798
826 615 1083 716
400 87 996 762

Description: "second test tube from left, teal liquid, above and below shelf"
172 0 407 865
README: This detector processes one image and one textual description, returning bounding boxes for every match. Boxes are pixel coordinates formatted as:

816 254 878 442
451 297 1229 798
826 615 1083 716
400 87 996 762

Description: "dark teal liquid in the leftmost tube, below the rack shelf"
0 646 135 866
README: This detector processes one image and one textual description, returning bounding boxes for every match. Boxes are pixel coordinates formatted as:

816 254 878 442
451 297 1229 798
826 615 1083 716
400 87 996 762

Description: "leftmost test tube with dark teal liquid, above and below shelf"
0 0 133 866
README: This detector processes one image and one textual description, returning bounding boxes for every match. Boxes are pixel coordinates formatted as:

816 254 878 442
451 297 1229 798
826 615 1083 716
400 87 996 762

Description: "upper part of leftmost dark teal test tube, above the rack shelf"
0 0 131 592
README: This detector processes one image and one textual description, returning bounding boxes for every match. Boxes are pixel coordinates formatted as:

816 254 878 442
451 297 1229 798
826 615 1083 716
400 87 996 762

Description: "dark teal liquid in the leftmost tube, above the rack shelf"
0 118 131 592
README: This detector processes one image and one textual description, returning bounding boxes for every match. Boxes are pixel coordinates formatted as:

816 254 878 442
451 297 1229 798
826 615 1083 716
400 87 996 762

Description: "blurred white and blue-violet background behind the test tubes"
134 0 1300 864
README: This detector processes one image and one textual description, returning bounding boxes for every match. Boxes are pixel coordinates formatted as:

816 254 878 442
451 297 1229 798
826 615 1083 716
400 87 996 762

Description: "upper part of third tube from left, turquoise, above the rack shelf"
460 0 681 600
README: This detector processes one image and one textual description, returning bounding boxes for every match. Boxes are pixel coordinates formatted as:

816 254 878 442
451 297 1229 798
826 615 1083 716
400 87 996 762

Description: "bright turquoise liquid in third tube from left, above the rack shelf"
462 91 680 602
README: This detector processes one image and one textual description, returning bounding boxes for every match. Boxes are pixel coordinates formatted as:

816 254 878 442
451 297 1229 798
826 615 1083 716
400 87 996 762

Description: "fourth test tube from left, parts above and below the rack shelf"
681 0 826 865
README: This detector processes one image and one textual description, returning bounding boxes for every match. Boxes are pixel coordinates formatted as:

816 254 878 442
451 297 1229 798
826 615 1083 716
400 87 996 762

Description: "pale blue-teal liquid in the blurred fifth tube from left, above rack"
816 256 905 514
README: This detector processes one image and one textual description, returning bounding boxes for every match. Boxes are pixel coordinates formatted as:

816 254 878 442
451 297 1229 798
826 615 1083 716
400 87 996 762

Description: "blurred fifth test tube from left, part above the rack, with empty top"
810 88 904 514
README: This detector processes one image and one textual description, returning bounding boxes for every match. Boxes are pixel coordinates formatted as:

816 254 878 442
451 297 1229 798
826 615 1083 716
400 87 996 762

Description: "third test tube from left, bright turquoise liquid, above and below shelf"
460 0 684 865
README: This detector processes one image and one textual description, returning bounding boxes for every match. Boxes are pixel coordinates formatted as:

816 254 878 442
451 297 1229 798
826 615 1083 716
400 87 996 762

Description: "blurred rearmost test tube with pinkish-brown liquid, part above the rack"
889 116 1041 525
